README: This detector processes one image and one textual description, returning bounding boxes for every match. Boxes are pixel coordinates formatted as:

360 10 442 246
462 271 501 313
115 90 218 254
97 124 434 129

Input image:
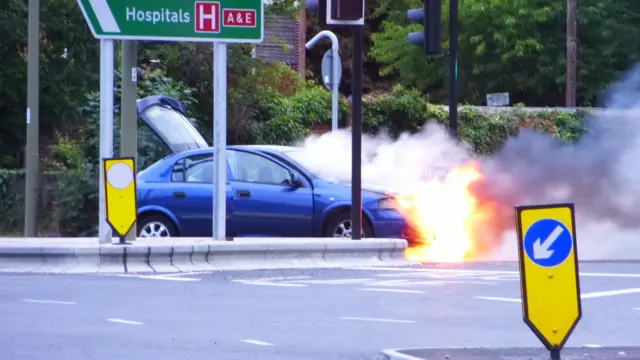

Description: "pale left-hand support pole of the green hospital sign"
98 40 114 243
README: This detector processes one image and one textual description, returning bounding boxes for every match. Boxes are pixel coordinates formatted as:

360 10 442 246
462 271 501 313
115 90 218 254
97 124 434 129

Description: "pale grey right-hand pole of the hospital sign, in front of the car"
213 42 227 240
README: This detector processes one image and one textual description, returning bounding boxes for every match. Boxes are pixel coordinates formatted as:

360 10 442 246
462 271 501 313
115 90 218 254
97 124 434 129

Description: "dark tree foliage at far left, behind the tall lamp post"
0 0 99 167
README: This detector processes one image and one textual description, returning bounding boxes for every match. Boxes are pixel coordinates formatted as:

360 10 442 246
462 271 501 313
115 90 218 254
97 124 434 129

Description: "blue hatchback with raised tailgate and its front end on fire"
137 96 410 239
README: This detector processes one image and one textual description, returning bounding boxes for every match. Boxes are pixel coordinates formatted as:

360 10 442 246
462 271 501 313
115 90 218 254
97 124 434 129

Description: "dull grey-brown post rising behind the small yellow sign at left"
120 40 138 241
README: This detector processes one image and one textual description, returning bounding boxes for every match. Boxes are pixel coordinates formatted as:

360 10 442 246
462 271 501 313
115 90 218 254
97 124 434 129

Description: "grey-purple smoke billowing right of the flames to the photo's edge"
476 63 640 230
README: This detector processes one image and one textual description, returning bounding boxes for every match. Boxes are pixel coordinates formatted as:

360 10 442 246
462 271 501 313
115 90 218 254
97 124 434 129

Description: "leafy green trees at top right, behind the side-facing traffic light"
372 0 640 106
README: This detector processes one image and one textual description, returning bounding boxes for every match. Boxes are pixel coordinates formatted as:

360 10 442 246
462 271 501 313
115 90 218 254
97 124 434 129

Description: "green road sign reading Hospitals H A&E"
78 0 264 43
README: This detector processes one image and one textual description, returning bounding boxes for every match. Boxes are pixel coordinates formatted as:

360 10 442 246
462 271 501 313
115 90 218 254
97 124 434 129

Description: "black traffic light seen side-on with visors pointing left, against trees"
407 0 442 55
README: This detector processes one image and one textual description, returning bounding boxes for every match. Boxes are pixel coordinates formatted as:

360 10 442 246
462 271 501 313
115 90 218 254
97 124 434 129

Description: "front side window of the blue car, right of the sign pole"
227 150 291 185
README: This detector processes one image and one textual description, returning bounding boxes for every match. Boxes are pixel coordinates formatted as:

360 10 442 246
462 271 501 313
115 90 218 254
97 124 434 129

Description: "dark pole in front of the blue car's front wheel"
351 25 362 240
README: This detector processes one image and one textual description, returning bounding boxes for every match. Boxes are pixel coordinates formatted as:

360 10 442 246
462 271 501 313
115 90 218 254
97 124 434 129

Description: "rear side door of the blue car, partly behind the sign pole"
166 152 233 237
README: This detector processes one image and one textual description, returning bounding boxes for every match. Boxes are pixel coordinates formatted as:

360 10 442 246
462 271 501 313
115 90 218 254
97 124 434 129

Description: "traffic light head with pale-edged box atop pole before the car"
304 0 364 26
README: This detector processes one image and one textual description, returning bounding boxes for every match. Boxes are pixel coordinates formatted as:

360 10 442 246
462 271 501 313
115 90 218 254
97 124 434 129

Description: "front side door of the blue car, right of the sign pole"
227 149 313 237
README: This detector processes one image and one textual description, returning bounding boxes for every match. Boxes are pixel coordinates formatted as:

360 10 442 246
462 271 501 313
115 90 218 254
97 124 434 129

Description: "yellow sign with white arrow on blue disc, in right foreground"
516 204 582 351
